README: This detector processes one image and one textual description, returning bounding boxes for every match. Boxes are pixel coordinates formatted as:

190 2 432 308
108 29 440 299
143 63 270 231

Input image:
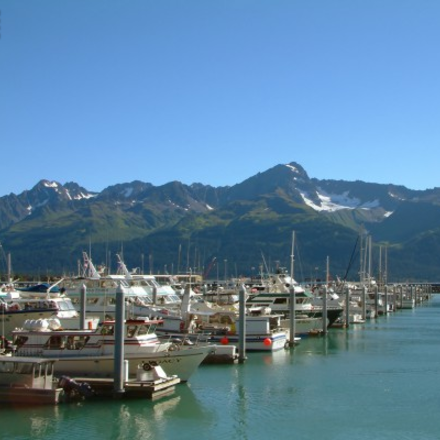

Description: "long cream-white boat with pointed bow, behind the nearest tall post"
13 319 212 382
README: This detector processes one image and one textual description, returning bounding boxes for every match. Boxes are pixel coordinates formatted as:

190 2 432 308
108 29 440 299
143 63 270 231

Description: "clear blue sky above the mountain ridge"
0 0 440 196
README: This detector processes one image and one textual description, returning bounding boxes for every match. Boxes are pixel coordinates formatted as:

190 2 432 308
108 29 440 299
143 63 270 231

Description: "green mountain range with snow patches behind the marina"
0 162 440 282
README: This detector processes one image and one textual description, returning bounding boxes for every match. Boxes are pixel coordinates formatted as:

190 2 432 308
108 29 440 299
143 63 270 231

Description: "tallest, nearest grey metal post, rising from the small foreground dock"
113 285 125 397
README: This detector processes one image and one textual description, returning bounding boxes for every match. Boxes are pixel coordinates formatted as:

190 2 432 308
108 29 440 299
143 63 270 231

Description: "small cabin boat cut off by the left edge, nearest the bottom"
0 356 63 405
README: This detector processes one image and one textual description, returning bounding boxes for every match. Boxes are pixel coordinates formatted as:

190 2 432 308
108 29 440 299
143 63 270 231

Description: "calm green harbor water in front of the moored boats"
0 297 440 440
